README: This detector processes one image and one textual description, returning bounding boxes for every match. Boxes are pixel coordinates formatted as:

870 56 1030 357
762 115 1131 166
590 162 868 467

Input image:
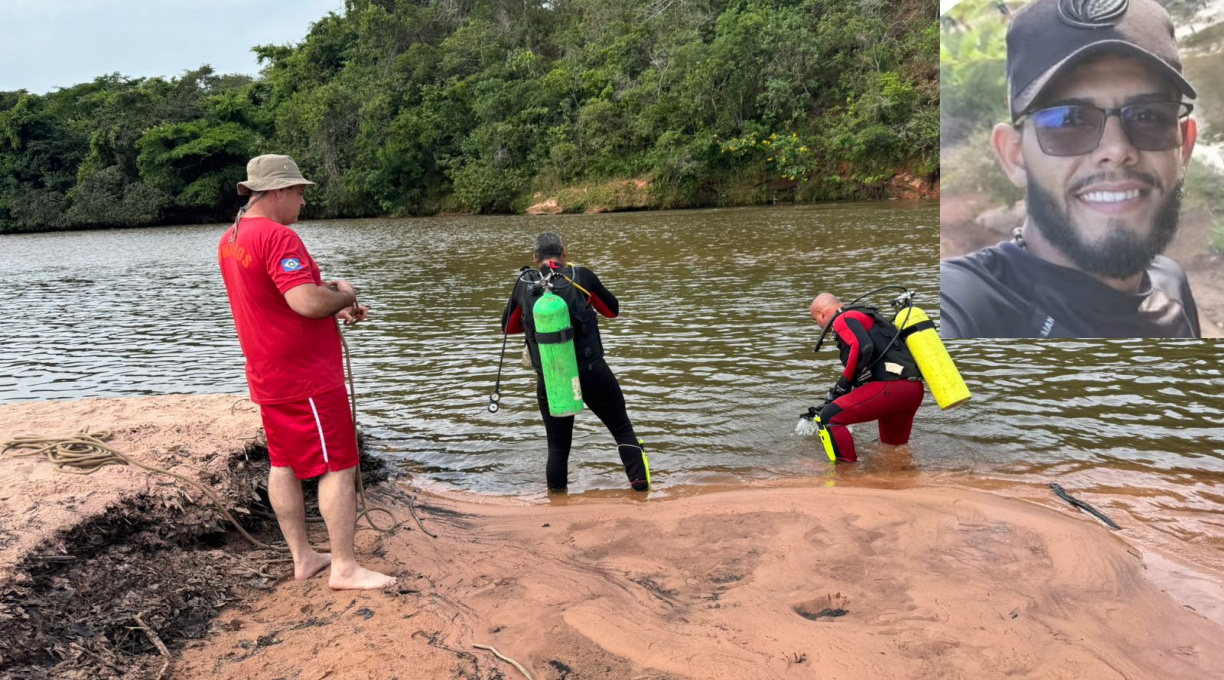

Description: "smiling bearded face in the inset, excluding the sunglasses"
994 54 1195 278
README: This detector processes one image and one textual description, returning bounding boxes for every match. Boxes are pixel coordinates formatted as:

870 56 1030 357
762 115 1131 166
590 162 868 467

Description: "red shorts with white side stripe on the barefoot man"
259 385 357 479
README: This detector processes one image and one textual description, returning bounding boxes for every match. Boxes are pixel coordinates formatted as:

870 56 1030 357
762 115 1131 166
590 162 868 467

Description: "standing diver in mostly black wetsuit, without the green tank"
502 234 650 492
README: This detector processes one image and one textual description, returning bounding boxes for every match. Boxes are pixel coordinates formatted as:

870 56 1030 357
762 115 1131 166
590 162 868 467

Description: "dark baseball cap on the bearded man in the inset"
1007 0 1197 120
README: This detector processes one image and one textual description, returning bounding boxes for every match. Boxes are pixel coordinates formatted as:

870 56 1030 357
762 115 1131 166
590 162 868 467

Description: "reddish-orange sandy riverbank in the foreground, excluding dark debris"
0 396 1224 680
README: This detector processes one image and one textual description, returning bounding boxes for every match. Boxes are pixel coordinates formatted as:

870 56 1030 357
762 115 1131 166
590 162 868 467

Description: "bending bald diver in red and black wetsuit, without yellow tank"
812 292 923 461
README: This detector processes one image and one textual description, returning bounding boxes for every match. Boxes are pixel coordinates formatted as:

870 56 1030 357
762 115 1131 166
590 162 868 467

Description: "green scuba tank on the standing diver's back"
531 291 583 418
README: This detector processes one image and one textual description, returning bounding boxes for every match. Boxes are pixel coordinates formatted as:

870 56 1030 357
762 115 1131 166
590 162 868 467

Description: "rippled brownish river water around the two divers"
0 202 1224 567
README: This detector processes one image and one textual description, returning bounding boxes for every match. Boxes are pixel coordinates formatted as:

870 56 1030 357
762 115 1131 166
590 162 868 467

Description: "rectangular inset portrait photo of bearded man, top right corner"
939 0 1224 339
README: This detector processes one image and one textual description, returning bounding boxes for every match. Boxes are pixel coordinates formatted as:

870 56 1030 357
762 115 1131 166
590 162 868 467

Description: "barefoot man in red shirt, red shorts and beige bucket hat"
217 155 395 589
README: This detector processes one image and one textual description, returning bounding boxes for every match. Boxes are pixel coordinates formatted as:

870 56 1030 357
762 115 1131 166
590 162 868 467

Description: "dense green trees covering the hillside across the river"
0 0 939 232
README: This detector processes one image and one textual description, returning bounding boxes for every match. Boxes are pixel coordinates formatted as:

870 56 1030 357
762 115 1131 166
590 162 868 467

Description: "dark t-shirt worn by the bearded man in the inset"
939 241 1200 339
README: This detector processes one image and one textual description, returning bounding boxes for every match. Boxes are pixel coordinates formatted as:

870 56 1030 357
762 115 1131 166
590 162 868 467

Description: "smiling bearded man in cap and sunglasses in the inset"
940 0 1200 338
